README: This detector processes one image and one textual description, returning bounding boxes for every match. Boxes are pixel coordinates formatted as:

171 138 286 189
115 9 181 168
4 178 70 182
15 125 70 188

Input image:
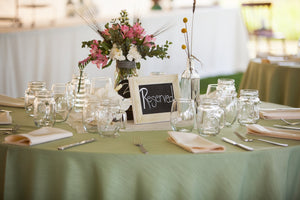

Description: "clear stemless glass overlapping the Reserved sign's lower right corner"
170 98 196 132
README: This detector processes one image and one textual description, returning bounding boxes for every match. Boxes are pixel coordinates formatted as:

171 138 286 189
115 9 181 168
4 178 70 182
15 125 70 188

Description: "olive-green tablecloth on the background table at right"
240 60 300 107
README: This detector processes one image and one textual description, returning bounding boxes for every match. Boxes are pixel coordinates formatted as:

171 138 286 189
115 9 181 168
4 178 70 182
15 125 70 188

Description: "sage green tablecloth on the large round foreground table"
0 104 300 200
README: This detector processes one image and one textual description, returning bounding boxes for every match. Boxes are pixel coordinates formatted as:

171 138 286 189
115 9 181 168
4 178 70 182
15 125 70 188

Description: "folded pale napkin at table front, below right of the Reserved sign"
168 131 225 153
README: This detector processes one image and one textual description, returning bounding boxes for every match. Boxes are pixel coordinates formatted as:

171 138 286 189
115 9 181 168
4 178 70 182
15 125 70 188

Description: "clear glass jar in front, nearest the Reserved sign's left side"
97 101 122 137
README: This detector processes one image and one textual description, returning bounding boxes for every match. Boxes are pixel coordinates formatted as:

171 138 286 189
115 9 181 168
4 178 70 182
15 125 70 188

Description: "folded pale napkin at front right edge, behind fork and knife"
247 124 300 140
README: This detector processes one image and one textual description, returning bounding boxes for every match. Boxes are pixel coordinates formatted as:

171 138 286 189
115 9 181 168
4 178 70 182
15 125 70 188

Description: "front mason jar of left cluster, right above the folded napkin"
33 90 55 127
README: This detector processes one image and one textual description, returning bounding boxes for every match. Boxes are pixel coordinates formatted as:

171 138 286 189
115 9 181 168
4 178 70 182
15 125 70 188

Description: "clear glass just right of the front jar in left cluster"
51 83 72 122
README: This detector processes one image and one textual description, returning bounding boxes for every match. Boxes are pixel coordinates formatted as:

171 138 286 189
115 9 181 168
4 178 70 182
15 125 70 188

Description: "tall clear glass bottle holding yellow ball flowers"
180 57 200 106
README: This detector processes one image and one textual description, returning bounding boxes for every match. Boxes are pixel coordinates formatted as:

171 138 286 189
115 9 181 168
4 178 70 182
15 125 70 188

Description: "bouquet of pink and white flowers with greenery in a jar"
78 10 171 97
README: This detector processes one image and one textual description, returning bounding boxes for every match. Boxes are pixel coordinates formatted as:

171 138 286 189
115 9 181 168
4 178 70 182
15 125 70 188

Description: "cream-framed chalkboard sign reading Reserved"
129 75 179 124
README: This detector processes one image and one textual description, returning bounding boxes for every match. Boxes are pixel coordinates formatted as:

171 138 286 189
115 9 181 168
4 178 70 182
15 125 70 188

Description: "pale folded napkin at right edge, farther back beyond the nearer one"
259 108 300 119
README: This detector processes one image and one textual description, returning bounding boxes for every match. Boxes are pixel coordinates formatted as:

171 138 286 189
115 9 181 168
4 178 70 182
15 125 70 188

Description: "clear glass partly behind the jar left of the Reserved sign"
82 99 100 133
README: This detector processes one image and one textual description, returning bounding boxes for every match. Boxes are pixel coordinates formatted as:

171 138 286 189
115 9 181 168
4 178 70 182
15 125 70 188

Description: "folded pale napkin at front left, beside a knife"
4 127 73 146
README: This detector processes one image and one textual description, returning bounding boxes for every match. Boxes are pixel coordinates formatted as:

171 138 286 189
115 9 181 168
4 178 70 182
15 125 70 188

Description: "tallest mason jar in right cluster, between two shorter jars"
217 78 237 126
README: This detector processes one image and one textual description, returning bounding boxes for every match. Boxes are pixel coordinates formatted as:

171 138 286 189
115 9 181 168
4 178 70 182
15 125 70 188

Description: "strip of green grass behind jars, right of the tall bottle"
200 72 244 94
